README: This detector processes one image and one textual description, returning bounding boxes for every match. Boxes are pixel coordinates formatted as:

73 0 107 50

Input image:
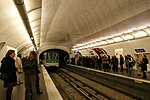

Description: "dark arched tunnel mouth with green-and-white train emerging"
40 49 69 70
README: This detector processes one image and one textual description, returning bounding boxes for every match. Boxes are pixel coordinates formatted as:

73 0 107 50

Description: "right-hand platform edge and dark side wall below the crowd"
64 64 150 100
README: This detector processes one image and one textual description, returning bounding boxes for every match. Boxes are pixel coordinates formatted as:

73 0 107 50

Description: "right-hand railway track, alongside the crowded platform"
51 69 134 100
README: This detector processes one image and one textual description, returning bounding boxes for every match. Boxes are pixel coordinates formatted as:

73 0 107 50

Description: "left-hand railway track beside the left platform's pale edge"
50 73 87 100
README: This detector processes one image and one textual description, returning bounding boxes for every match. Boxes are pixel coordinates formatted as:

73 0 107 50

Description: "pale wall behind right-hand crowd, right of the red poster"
100 37 150 71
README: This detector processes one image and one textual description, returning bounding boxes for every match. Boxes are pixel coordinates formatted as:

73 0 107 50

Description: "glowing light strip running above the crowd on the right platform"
74 26 150 50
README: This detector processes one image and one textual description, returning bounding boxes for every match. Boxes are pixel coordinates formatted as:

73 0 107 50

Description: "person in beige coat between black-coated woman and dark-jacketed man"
15 54 23 85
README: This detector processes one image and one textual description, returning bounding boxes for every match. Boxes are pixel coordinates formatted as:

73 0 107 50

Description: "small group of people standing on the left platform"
0 50 42 100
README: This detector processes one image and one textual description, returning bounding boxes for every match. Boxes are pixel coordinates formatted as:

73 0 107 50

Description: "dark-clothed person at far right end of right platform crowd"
141 55 149 79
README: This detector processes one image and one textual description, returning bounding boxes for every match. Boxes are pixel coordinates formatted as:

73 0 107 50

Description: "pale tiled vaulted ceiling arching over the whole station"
0 0 150 54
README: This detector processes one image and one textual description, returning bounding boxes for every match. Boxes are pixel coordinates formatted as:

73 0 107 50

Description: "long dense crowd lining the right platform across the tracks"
70 55 148 79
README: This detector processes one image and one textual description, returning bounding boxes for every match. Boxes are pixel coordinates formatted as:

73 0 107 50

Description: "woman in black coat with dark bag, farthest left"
0 50 17 100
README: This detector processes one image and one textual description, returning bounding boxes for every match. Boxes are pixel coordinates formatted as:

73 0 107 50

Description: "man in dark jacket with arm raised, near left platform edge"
23 51 38 100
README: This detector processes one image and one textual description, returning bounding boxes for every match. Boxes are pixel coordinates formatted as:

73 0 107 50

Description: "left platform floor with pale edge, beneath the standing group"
0 65 63 100
